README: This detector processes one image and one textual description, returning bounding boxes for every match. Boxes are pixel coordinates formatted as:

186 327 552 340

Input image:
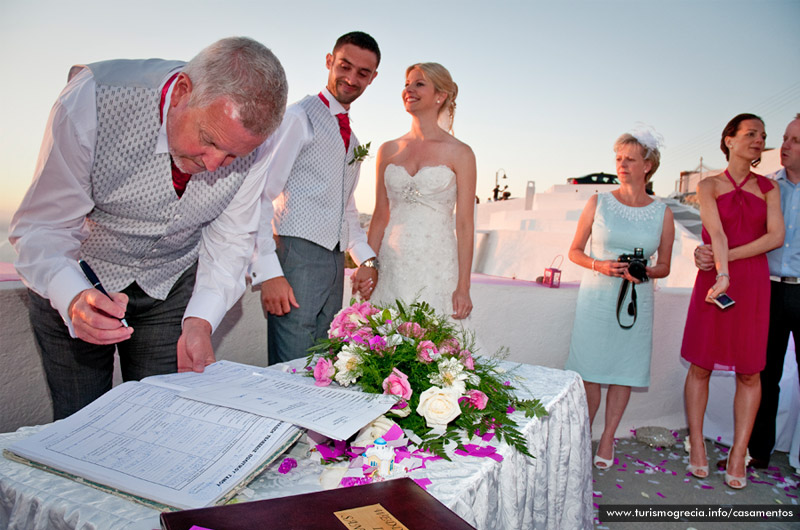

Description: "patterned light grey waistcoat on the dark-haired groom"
273 96 359 251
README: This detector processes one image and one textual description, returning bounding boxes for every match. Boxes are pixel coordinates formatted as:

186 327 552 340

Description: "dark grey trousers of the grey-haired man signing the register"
28 264 197 420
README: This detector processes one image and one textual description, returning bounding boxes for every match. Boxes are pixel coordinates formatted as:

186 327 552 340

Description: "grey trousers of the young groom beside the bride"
267 236 344 364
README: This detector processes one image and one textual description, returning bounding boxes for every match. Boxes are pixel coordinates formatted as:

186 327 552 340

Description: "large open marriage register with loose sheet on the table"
5 361 396 509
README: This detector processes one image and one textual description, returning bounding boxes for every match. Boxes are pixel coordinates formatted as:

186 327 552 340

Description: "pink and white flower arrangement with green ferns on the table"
306 301 547 458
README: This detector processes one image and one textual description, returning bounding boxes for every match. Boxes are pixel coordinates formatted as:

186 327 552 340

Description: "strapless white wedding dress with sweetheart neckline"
371 164 458 316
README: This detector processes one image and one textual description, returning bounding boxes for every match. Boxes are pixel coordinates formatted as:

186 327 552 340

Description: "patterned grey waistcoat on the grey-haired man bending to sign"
73 59 254 300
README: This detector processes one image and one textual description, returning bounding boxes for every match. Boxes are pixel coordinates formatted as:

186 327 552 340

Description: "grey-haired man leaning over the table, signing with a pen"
9 37 287 419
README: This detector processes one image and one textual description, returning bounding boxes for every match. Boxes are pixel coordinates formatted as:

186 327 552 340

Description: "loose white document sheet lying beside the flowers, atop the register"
162 361 397 440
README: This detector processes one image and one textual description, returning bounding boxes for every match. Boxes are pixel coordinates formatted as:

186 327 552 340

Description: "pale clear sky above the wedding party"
0 0 800 228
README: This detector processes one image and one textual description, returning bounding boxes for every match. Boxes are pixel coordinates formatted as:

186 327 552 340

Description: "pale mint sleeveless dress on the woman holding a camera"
564 193 666 387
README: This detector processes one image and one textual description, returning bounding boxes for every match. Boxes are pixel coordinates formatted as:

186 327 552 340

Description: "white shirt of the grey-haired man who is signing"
9 65 267 330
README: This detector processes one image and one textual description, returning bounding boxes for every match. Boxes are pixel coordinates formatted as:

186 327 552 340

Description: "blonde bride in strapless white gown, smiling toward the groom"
355 63 476 319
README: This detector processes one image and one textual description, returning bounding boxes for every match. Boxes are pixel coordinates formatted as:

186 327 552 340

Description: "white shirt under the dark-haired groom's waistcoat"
250 88 375 285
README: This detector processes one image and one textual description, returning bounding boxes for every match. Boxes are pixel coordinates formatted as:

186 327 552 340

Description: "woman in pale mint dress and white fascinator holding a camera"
564 129 675 469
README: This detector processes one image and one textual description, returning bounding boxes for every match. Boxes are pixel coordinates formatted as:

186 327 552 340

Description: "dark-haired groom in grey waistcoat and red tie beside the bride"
250 31 381 364
